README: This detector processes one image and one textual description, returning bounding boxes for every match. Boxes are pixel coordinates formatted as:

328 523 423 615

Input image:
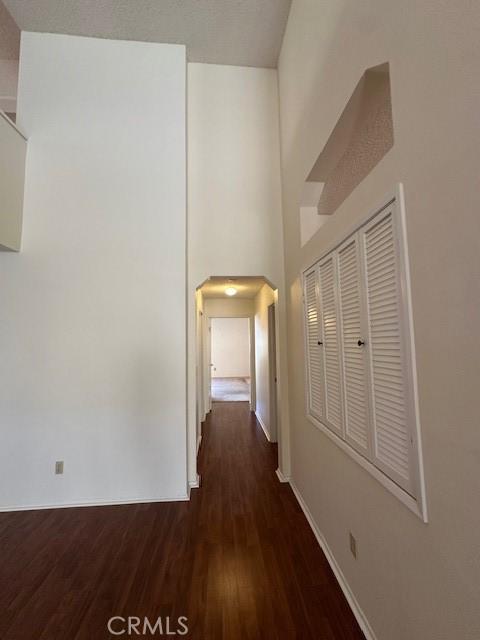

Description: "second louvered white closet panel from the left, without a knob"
318 255 343 435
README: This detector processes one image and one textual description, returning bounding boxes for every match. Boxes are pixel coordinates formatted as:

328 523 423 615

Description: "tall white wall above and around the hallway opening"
188 64 288 481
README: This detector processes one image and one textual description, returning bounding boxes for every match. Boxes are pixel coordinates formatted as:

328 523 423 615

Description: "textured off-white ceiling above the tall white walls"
4 0 291 68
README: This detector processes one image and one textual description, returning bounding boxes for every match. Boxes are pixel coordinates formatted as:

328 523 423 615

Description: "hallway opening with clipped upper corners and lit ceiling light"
196 276 280 442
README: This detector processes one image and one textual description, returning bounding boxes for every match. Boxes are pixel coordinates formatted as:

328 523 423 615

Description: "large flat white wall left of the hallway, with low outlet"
0 33 186 507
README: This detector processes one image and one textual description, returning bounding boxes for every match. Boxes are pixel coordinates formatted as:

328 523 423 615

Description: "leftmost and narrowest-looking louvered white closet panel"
304 268 325 420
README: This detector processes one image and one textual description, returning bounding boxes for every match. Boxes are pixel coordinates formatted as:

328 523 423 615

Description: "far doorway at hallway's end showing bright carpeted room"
210 318 251 402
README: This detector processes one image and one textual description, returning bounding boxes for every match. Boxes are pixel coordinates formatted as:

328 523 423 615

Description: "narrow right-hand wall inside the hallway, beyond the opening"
255 284 276 440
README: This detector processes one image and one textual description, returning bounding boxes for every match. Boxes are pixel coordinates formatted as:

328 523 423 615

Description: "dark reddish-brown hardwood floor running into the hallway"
0 403 363 640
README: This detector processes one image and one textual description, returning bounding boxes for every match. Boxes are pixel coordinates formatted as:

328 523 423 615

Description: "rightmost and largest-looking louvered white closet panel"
361 205 413 493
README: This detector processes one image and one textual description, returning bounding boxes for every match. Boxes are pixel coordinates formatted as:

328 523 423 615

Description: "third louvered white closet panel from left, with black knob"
338 235 371 457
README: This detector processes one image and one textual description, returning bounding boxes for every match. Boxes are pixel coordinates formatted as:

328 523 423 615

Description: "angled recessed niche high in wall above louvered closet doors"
300 63 393 247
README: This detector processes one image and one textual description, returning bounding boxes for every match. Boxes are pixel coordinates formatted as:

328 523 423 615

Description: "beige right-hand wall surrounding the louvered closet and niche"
279 0 480 640
